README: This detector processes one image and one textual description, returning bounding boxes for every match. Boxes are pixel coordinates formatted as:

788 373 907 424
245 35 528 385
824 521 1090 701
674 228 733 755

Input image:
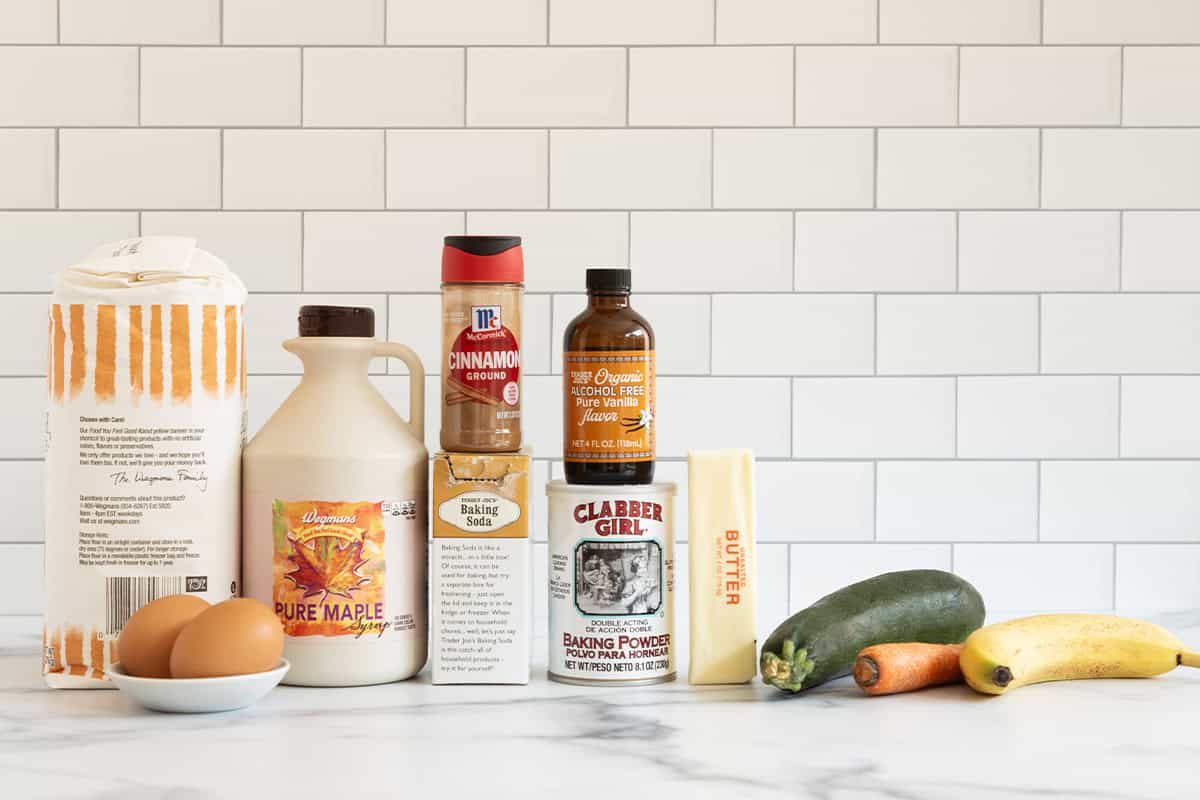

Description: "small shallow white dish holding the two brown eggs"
108 658 292 714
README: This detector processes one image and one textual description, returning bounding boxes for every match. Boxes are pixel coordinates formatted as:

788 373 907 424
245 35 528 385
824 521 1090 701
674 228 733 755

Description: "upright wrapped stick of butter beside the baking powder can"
688 450 757 684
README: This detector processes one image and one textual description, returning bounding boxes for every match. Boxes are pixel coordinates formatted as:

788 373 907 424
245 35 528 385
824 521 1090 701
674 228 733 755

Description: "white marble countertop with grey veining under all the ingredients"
0 612 1200 800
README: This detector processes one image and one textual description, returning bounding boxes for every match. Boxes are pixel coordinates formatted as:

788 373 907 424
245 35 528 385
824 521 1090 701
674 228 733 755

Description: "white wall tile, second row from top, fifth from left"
629 47 792 126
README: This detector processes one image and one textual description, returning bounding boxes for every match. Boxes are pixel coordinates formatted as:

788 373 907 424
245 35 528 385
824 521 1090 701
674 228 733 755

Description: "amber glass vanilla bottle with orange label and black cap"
563 269 656 485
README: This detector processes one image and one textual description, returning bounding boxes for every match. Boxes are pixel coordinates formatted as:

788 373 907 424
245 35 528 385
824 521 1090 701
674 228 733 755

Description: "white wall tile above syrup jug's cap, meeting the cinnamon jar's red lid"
304 211 463 291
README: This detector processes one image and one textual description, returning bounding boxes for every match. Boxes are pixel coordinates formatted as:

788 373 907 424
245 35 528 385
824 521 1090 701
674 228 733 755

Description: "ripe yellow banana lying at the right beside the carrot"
959 614 1200 694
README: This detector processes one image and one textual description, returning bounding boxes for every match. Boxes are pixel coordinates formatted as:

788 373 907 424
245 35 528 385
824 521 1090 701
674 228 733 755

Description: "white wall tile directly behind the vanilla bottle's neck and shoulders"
551 293 712 375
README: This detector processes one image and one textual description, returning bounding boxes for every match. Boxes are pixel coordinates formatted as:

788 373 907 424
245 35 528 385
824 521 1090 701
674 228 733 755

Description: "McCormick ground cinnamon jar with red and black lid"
440 236 524 452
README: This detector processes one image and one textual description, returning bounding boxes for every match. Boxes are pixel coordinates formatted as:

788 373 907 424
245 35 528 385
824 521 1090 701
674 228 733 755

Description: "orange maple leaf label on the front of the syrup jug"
274 501 386 636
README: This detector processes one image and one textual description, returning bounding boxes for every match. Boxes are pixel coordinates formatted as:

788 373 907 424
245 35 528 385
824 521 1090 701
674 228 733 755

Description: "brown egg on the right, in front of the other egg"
170 597 283 678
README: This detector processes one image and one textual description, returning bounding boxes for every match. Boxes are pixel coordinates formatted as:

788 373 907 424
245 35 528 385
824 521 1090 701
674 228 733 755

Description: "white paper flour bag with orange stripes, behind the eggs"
42 236 246 688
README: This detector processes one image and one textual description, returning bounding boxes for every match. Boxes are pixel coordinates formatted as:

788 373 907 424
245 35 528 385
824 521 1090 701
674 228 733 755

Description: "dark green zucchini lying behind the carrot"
760 570 984 692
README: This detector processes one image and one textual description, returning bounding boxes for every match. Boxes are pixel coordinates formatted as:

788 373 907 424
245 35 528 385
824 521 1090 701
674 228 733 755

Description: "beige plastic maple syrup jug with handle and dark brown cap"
242 306 428 686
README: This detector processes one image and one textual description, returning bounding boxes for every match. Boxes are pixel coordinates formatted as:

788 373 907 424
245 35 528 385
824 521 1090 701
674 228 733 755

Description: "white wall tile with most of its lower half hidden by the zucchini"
788 543 950 612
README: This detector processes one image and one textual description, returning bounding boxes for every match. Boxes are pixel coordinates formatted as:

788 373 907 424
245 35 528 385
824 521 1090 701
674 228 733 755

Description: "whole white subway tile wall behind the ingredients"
0 0 1200 618
